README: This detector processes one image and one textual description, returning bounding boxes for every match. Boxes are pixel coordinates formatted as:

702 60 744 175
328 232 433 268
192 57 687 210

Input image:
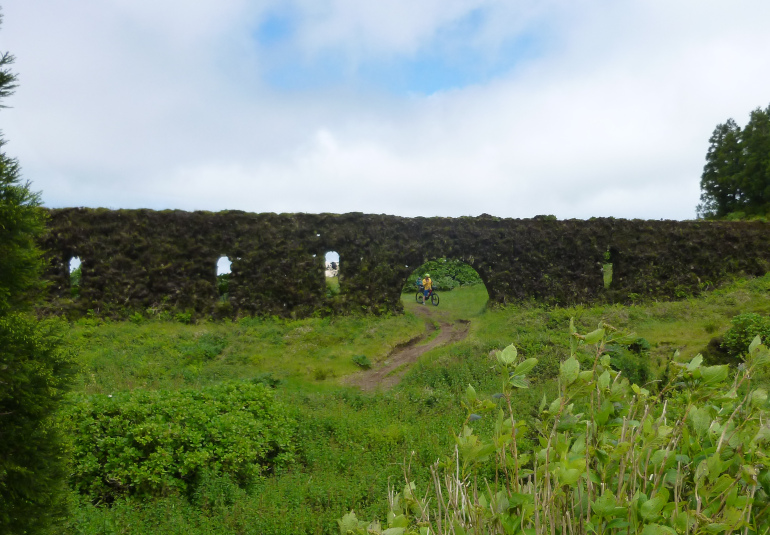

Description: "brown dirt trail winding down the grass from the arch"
343 307 470 390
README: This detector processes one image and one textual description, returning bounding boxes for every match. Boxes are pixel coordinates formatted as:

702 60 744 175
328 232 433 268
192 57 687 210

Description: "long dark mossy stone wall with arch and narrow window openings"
42 208 770 317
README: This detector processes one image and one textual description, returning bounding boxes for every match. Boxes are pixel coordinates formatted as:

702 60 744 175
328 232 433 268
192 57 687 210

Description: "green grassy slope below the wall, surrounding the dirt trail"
60 277 770 535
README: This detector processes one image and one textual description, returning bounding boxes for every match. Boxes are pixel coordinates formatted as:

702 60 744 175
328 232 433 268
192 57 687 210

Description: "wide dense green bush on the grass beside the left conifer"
64 383 295 501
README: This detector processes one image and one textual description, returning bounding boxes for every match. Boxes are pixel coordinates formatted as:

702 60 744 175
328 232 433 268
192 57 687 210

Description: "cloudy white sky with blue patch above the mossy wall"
0 0 770 220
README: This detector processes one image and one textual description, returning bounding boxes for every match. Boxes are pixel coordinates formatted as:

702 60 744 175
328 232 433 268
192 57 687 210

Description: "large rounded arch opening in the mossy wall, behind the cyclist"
401 258 489 312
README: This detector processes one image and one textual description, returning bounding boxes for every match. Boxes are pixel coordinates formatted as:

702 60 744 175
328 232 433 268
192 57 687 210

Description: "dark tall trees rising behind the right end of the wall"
697 105 770 218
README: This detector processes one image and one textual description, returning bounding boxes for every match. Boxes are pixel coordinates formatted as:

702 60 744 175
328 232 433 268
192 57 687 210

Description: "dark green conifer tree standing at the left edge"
0 12 72 534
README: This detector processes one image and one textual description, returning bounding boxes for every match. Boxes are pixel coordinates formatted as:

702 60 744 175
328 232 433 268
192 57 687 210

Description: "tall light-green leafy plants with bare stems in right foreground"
338 323 770 535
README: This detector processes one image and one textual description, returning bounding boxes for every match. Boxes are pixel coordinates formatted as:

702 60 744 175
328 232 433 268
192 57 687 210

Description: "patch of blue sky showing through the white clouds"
255 9 543 95
